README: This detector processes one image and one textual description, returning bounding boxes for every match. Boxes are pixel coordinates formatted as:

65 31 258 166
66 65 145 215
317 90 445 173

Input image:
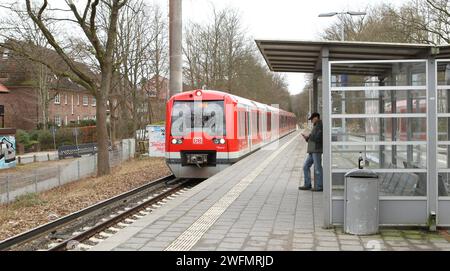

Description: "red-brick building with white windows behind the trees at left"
0 49 96 130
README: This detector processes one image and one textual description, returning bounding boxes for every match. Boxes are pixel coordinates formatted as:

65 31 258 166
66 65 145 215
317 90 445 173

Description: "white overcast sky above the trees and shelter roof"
147 0 406 94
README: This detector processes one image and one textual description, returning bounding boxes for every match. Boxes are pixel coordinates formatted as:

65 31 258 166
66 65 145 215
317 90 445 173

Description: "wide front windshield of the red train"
171 101 225 136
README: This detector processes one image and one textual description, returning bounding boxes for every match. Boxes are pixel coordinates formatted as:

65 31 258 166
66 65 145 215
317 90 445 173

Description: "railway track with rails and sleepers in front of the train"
0 175 197 251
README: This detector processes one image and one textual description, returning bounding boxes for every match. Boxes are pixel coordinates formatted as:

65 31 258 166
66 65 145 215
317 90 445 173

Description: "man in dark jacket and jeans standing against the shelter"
299 113 323 192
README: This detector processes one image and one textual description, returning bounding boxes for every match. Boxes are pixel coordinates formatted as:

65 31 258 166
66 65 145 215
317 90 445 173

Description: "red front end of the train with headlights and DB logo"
166 90 229 178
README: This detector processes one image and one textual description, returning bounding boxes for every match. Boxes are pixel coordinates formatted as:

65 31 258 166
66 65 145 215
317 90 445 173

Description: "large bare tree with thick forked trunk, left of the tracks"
0 0 127 176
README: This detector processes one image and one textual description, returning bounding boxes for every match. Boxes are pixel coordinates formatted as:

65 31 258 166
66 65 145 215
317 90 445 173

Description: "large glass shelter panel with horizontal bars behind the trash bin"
330 60 428 200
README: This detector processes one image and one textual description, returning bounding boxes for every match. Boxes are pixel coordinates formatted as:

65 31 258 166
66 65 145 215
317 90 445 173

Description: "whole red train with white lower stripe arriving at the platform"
166 90 297 178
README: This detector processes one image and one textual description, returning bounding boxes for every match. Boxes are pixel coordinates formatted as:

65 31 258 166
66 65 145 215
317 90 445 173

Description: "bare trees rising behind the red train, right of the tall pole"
183 5 291 110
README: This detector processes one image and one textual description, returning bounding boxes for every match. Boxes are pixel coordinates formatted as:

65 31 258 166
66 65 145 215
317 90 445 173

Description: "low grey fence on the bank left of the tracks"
0 139 135 203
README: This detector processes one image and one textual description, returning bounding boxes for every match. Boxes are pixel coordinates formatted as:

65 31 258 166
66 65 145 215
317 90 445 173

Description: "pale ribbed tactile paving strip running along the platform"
165 134 299 251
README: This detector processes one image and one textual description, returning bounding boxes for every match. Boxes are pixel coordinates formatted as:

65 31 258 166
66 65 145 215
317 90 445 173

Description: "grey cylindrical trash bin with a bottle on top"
344 169 379 235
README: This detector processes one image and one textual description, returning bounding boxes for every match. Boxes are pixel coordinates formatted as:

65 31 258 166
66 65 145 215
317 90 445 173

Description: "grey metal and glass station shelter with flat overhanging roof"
256 40 450 227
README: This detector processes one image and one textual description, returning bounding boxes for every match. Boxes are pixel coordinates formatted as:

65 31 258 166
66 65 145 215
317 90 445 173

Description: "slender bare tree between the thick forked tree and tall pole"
110 0 168 144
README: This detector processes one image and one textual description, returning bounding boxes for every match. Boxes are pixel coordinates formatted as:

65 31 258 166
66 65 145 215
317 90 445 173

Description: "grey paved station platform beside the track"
92 132 450 251
